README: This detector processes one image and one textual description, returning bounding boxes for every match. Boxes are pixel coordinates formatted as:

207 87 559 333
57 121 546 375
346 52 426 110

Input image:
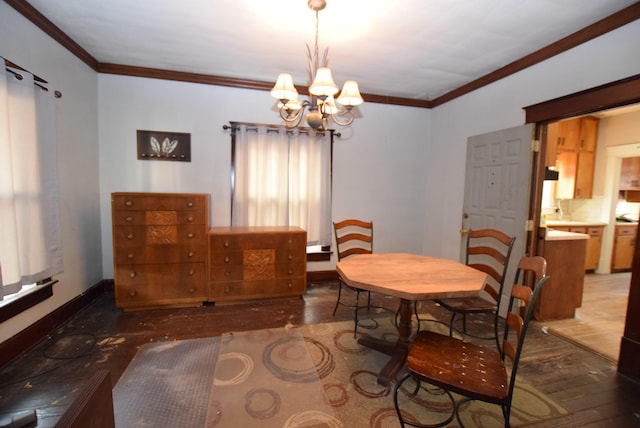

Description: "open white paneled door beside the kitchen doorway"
461 125 534 315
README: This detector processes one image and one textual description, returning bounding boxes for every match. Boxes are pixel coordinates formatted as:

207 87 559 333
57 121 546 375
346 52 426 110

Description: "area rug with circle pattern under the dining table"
113 318 568 428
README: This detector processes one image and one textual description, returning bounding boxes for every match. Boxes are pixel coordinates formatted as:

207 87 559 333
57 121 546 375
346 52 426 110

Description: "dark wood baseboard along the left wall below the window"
0 281 105 368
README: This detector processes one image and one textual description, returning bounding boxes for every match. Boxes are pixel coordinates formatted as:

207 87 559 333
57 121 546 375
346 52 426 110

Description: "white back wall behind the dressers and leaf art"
98 75 431 278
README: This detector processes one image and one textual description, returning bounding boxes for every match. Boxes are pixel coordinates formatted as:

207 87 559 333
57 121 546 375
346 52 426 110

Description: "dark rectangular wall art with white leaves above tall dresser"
137 130 191 162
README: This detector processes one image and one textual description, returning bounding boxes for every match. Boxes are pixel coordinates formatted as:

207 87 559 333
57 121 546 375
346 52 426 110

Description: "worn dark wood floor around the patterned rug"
0 284 640 428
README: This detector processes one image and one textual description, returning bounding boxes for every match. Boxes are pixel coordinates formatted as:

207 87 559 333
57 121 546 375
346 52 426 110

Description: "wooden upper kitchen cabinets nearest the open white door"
547 116 598 199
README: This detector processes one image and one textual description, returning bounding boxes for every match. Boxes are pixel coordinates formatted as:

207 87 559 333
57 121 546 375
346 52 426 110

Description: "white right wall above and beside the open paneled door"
424 21 640 258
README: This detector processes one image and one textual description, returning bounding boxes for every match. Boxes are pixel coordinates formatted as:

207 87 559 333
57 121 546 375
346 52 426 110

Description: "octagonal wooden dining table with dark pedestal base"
336 253 487 386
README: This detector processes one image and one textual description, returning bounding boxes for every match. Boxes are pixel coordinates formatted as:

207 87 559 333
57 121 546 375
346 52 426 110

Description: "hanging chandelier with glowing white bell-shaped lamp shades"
271 0 364 129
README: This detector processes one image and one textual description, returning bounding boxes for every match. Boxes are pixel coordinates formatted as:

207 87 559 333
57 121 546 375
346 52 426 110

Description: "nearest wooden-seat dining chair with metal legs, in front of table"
394 256 549 427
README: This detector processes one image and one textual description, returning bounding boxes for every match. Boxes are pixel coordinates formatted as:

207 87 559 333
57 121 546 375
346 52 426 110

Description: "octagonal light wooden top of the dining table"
336 253 487 300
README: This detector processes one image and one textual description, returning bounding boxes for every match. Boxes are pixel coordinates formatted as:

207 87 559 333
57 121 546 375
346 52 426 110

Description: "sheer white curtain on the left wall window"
0 65 62 299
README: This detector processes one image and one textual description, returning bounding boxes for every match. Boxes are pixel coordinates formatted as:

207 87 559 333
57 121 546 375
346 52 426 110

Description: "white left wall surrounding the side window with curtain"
0 2 103 342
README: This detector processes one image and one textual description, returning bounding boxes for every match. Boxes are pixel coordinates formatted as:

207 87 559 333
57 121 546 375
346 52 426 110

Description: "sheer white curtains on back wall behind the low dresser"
232 124 331 245
